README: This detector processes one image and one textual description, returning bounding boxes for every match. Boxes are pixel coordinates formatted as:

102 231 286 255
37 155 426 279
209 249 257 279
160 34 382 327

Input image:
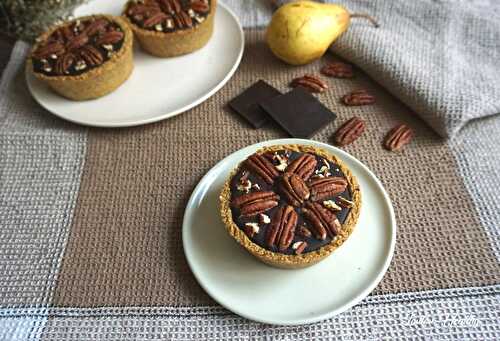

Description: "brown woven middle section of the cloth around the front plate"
45 30 500 307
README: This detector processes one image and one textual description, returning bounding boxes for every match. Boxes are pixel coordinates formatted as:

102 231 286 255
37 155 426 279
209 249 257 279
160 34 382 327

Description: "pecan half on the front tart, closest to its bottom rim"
266 205 298 251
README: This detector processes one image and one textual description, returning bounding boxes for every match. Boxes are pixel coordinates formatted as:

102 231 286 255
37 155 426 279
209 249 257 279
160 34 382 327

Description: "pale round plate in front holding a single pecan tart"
182 139 396 325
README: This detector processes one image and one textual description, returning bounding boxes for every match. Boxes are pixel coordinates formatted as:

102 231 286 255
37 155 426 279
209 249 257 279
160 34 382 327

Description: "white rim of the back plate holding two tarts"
25 0 245 128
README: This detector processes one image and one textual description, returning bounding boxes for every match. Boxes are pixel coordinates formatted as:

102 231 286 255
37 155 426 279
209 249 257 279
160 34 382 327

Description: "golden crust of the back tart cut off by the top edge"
123 0 217 57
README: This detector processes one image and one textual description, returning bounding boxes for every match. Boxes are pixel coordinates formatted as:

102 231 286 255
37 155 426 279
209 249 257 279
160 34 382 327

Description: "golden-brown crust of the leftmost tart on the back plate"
26 15 134 101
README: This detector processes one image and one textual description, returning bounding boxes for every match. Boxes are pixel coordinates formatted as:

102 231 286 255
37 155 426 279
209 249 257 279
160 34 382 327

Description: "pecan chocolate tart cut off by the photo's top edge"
124 0 217 57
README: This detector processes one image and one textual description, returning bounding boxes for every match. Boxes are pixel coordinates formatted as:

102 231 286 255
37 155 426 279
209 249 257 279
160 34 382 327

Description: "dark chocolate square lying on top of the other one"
260 86 337 138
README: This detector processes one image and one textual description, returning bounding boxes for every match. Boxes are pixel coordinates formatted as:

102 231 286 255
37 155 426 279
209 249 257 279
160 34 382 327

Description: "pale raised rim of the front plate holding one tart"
182 138 397 326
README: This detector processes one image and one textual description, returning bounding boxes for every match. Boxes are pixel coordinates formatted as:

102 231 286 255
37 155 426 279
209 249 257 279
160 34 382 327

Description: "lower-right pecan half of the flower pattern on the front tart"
302 202 341 240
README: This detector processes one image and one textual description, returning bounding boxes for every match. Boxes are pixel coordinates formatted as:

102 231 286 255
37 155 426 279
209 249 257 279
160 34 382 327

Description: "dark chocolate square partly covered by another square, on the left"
229 80 281 128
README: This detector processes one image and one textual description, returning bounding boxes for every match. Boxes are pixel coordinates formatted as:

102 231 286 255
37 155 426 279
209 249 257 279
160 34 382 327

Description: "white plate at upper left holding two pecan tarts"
27 0 244 127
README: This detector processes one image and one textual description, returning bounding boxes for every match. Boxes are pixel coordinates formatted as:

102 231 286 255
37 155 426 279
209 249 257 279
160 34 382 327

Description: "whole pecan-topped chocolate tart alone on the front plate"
220 145 361 268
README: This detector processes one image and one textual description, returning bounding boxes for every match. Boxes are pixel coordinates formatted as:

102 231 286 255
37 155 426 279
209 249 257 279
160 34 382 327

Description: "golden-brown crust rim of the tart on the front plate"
220 145 361 269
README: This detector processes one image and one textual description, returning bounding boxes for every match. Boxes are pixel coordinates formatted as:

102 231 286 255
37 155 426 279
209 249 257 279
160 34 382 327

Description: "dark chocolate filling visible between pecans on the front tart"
230 150 352 255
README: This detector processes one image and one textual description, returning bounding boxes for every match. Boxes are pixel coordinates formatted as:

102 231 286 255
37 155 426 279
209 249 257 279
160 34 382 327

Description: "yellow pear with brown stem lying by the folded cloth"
266 1 376 65
